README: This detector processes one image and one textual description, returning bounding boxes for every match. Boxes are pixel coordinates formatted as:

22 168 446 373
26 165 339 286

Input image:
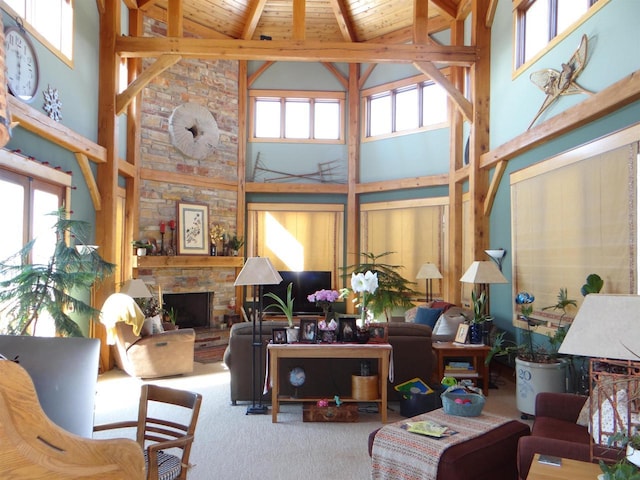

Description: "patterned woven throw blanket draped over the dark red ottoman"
371 409 510 480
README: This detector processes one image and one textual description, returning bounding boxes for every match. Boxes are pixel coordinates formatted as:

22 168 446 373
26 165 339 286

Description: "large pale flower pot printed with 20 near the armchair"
516 358 567 415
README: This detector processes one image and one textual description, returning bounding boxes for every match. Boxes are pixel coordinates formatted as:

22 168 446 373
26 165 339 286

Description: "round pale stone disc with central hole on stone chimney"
169 103 220 160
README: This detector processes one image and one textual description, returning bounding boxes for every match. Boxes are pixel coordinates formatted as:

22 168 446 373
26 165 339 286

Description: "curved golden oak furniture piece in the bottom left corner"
0 360 144 480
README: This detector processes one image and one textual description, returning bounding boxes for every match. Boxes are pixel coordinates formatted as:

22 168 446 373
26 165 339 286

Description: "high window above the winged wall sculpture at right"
514 0 609 68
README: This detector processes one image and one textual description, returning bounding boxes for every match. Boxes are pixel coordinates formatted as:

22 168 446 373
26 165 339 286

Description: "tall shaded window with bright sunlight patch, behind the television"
247 203 344 284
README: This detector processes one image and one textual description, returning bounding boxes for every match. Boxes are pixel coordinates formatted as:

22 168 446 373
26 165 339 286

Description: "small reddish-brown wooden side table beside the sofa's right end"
432 342 491 396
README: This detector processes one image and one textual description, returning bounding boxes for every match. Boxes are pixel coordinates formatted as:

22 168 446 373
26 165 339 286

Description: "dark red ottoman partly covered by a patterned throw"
369 414 530 480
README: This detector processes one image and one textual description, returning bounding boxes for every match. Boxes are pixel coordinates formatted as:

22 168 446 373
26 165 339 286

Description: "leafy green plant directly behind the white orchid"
343 252 418 321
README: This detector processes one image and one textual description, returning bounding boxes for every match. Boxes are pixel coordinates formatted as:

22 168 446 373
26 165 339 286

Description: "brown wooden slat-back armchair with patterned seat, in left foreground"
94 384 202 480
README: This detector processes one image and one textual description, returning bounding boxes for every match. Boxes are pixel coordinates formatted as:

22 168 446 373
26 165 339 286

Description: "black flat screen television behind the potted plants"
262 271 331 315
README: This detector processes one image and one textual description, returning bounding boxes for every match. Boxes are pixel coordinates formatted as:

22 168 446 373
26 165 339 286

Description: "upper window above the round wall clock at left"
2 0 73 62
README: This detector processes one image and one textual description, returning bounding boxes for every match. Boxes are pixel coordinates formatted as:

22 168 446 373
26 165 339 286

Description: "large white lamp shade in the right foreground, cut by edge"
558 293 640 361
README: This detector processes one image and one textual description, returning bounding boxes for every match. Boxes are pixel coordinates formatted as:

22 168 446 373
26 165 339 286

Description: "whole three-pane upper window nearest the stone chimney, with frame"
250 90 345 143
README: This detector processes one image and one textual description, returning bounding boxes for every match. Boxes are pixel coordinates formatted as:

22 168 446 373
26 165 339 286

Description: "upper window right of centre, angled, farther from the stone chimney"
362 77 447 138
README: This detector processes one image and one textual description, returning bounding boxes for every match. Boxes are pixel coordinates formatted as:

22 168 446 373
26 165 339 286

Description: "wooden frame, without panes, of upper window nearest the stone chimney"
249 90 346 144
